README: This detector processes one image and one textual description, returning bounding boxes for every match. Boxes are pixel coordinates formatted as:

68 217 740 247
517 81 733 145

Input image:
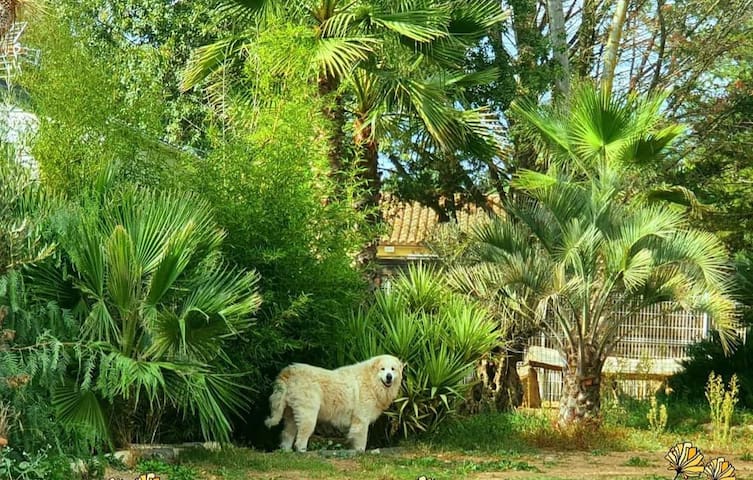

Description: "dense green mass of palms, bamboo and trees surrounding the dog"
0 0 753 464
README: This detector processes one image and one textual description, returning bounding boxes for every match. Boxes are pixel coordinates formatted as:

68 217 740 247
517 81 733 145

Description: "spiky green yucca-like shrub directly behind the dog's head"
340 266 498 436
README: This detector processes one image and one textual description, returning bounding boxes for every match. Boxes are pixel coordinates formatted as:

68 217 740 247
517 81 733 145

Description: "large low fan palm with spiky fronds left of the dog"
30 190 261 442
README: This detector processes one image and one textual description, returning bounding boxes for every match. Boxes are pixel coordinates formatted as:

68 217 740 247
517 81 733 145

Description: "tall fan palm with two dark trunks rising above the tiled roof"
182 0 505 220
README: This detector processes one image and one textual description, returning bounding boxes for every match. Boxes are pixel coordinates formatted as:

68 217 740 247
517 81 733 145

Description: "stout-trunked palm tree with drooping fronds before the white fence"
458 85 734 424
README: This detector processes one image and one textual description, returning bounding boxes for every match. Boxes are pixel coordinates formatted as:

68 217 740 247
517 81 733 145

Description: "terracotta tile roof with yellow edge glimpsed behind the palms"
377 194 501 258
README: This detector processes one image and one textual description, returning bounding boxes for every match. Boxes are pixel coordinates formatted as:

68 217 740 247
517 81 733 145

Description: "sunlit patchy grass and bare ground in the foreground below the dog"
150 403 753 480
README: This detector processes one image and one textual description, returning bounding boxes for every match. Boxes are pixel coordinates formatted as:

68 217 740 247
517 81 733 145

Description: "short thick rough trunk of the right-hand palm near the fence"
557 345 604 426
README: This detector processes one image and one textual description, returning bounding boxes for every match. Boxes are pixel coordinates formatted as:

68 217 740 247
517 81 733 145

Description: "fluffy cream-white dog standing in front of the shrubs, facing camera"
264 355 403 452
